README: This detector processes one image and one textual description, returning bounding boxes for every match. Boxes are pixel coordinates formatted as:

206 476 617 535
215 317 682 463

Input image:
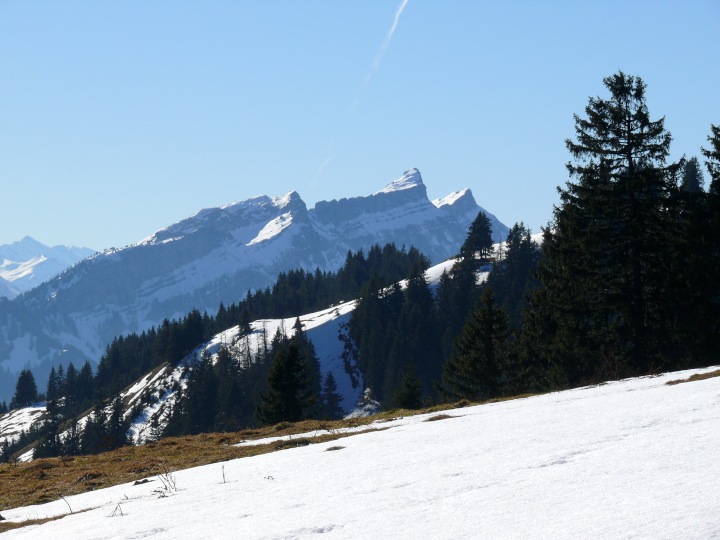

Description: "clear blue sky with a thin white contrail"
0 0 720 249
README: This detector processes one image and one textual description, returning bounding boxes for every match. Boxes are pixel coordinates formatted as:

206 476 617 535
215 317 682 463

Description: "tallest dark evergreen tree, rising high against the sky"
534 72 679 385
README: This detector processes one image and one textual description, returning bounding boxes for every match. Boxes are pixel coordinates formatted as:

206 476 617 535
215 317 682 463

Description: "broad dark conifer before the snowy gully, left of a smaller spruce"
256 341 318 424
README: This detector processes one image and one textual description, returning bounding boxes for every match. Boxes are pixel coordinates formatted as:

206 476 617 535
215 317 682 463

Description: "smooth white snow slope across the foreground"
2 372 720 540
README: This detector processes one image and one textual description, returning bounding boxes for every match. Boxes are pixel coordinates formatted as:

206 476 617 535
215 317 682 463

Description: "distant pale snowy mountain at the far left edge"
0 236 95 298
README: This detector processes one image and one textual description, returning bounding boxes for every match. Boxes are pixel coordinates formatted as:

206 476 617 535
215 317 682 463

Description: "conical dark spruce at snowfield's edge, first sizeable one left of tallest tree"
439 288 510 401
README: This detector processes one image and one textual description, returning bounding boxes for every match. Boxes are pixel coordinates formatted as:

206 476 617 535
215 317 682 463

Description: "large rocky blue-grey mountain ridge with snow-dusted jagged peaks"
0 169 508 396
